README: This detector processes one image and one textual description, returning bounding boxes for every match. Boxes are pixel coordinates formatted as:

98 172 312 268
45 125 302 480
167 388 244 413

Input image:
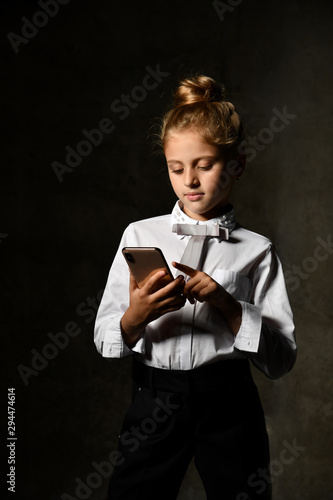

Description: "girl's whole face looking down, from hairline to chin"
164 130 234 220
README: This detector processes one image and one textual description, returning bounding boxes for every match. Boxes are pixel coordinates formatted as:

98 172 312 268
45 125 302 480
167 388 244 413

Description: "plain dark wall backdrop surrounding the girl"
0 0 333 500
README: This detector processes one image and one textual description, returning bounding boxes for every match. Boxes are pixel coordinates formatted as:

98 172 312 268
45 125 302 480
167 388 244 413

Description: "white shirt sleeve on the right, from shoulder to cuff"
235 246 297 379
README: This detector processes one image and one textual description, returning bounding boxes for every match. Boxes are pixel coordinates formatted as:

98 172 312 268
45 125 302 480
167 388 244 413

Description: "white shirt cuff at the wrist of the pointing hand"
234 301 261 352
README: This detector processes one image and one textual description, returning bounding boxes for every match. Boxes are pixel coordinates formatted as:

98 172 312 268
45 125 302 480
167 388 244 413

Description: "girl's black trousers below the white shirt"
108 360 271 500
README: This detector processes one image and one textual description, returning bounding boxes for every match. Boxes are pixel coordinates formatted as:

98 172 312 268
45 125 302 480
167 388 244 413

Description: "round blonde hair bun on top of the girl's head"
174 76 224 106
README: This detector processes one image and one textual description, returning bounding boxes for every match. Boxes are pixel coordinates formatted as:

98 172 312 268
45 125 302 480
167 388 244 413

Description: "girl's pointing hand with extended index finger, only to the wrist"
172 262 229 308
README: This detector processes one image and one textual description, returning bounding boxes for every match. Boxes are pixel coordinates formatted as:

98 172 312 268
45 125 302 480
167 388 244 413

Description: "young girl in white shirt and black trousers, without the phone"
95 76 296 500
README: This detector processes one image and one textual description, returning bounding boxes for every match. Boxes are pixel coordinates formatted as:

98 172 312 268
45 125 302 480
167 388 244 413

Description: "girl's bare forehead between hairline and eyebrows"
164 130 220 161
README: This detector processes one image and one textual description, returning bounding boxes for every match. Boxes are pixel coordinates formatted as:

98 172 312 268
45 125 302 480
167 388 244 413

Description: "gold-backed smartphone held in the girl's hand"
122 247 174 291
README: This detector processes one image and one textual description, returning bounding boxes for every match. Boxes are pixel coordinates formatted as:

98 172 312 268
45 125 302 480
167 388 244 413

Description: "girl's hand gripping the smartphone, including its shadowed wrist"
121 271 186 347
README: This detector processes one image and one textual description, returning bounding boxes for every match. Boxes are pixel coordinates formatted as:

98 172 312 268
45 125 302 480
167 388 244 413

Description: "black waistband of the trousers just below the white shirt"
132 358 252 393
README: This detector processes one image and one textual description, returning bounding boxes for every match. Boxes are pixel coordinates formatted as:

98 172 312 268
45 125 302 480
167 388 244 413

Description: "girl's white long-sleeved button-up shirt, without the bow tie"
95 202 296 379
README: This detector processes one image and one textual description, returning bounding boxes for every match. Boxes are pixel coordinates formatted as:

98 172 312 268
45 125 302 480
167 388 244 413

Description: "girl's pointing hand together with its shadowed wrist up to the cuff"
172 262 242 335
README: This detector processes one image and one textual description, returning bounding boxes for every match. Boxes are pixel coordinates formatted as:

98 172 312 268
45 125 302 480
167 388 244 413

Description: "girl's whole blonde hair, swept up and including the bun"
158 75 244 154
